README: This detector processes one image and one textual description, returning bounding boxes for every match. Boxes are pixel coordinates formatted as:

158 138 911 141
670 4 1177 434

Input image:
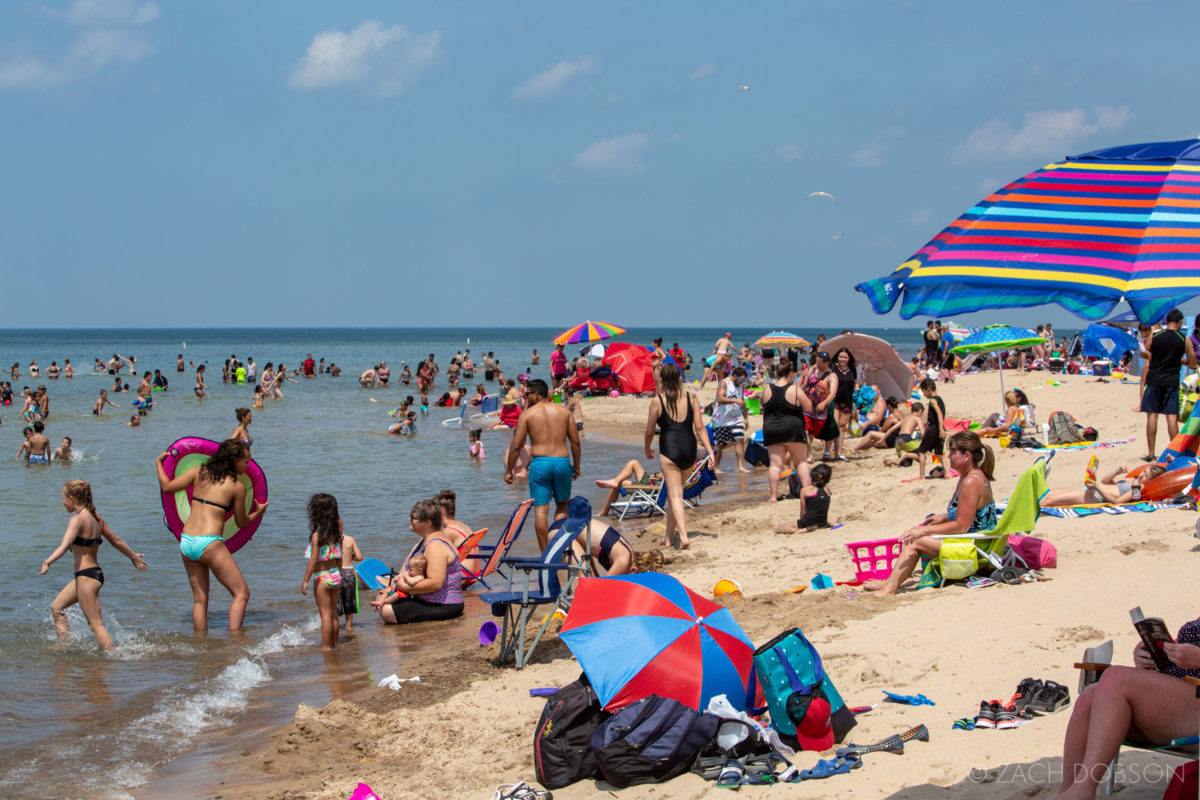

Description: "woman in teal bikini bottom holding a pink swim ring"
157 439 268 632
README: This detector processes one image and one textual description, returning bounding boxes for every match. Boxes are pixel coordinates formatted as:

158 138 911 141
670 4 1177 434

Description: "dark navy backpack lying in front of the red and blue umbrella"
592 694 720 788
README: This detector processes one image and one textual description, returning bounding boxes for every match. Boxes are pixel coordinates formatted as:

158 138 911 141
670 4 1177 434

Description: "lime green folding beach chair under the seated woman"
922 452 1054 585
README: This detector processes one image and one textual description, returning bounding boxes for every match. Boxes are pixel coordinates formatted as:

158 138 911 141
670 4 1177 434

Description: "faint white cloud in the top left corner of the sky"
0 0 158 91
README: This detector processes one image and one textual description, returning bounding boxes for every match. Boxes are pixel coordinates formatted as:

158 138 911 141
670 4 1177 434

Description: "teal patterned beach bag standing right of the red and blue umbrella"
754 627 854 745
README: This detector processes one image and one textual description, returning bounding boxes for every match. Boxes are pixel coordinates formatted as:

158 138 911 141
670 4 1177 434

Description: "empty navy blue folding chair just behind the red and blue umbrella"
480 497 592 669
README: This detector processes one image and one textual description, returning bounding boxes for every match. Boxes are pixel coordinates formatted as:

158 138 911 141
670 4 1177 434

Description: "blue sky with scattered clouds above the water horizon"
0 0 1200 327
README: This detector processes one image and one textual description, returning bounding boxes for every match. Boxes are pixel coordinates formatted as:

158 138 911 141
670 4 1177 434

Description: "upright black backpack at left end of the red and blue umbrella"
533 675 608 789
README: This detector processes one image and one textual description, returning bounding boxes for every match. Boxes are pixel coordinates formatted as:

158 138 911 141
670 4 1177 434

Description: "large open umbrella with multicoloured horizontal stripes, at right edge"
854 139 1200 323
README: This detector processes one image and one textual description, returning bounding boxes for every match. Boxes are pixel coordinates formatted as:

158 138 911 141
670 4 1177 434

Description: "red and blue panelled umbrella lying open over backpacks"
558 572 754 710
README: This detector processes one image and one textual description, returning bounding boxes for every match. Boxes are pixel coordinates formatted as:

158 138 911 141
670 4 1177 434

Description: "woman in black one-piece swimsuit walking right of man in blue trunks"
646 363 714 549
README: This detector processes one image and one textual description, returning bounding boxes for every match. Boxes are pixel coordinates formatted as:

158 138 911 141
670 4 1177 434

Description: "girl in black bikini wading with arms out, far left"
37 481 150 650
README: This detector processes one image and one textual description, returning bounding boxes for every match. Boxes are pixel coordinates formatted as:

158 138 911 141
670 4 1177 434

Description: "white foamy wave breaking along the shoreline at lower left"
0 618 320 800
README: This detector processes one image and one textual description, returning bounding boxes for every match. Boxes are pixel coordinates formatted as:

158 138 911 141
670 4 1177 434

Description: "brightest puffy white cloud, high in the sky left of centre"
290 19 442 97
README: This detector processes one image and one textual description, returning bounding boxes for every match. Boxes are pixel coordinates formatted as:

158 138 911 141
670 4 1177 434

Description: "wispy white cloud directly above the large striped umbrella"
950 106 1133 164
